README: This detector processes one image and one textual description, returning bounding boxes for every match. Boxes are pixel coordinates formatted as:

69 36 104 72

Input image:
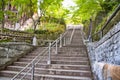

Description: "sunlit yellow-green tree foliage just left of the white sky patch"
40 0 67 24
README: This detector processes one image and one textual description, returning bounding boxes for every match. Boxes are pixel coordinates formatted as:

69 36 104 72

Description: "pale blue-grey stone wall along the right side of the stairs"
87 22 120 80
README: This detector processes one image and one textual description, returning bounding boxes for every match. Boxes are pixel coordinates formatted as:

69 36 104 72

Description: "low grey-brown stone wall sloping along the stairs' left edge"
0 42 34 69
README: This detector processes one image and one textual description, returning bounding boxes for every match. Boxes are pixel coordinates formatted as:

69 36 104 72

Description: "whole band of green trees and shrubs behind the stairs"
0 0 120 42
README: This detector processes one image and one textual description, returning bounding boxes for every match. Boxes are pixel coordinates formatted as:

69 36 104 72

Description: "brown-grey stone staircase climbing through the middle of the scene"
0 29 93 80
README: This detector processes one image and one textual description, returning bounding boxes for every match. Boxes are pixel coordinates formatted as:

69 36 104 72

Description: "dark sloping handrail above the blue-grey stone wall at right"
92 4 120 40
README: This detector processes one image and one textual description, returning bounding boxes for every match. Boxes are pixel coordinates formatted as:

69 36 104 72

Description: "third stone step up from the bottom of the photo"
14 62 90 70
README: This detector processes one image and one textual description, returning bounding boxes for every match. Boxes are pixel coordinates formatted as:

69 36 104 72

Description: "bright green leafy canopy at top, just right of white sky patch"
73 0 102 22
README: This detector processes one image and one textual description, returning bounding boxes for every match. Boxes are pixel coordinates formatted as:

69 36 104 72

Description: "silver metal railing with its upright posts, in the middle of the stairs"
11 31 67 80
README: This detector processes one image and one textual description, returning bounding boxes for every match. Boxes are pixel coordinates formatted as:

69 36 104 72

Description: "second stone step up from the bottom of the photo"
7 66 91 77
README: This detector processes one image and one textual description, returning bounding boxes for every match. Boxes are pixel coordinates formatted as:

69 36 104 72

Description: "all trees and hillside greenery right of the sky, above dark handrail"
70 0 120 39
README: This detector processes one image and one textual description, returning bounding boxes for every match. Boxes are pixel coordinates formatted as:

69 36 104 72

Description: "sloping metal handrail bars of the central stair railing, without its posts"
11 31 67 80
